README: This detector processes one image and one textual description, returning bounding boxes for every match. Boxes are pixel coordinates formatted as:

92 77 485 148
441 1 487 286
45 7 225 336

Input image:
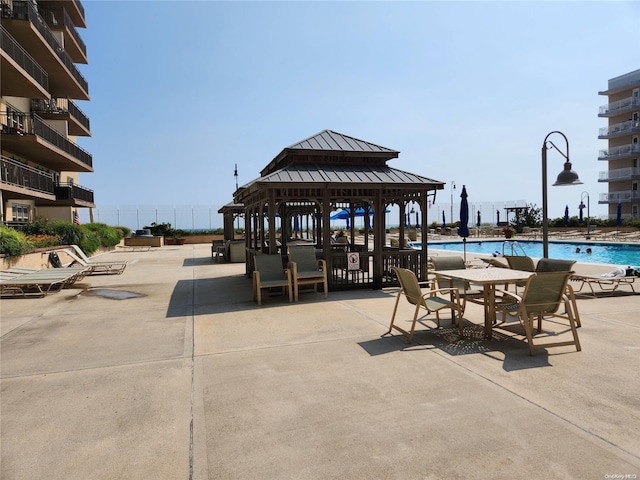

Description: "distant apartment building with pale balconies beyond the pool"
598 70 640 218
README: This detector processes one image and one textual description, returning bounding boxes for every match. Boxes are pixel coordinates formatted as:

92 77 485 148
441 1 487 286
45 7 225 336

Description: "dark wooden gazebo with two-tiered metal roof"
233 130 444 290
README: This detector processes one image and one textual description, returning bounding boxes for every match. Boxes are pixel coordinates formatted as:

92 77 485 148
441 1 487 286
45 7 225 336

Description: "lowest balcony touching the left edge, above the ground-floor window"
0 155 55 200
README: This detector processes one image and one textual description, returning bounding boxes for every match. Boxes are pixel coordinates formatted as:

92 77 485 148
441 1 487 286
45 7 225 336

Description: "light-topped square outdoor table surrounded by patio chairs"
433 268 534 339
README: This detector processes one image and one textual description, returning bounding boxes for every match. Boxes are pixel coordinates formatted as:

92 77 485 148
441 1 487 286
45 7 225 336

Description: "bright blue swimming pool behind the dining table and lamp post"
410 240 640 268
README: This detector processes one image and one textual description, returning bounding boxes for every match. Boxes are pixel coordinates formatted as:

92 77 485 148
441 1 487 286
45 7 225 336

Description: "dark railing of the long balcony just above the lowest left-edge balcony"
0 113 93 167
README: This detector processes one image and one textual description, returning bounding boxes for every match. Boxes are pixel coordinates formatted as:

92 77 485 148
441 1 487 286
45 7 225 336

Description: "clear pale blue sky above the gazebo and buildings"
72 0 640 227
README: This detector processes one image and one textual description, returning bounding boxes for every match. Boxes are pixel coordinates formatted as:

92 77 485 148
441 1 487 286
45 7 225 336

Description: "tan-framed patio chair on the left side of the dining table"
385 267 464 342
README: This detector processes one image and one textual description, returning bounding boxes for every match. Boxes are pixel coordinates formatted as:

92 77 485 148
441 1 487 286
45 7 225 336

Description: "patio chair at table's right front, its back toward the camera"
496 272 582 355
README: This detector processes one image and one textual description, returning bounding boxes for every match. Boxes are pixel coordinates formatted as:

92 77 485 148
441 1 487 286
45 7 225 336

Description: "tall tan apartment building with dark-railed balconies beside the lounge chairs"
0 0 95 225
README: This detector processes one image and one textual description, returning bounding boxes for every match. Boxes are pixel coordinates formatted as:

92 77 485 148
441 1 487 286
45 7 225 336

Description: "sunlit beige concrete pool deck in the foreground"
0 244 640 480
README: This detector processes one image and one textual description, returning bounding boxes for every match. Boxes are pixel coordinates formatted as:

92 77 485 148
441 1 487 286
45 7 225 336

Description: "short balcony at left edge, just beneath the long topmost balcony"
0 27 49 98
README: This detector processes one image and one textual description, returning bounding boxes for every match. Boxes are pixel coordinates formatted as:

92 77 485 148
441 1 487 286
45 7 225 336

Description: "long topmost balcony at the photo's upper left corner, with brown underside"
2 0 89 100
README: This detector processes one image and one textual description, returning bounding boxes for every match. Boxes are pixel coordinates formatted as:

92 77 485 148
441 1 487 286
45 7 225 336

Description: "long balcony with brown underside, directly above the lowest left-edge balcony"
0 113 93 172
